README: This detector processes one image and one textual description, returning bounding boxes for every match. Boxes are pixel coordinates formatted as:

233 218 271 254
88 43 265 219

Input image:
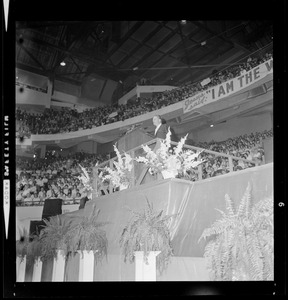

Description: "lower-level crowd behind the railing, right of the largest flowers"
195 129 273 179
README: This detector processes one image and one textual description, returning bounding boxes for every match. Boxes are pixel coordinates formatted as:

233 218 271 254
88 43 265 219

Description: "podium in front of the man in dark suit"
117 128 154 153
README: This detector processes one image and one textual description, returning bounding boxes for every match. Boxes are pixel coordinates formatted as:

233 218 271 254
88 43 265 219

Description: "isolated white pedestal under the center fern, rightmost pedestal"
134 251 161 281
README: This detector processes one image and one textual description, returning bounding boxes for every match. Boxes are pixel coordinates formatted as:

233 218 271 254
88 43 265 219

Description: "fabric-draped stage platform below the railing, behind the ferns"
27 163 273 281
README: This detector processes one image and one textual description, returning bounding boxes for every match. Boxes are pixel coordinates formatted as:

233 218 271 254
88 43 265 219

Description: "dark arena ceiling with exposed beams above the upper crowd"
16 20 273 102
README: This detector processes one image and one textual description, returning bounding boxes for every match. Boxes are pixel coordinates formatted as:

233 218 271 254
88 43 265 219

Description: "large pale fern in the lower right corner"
199 183 274 281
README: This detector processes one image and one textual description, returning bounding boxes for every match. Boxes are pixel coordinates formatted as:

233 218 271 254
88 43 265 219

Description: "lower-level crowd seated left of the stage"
16 152 109 206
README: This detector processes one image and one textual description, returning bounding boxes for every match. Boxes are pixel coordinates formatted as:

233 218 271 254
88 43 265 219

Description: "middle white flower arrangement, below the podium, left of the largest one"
99 145 133 187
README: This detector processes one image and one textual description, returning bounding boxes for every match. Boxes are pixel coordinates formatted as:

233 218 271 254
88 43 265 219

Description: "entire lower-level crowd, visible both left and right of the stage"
16 129 273 205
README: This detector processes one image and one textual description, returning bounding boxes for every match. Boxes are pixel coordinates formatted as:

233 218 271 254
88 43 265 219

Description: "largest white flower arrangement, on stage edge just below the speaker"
135 128 203 176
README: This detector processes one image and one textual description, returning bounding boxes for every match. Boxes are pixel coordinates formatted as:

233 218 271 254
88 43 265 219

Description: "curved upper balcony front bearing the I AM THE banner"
16 58 273 143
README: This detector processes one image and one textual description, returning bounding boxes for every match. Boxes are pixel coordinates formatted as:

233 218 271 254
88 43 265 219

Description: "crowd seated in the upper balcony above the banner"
16 53 272 137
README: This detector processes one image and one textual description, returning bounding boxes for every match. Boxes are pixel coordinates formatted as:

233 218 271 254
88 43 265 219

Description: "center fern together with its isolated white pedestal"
119 199 174 281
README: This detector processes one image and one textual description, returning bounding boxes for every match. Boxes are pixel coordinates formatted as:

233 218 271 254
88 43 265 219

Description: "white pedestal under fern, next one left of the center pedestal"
78 251 94 281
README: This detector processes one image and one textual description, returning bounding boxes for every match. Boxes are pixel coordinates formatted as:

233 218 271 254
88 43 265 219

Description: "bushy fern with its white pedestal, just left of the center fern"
65 205 108 281
